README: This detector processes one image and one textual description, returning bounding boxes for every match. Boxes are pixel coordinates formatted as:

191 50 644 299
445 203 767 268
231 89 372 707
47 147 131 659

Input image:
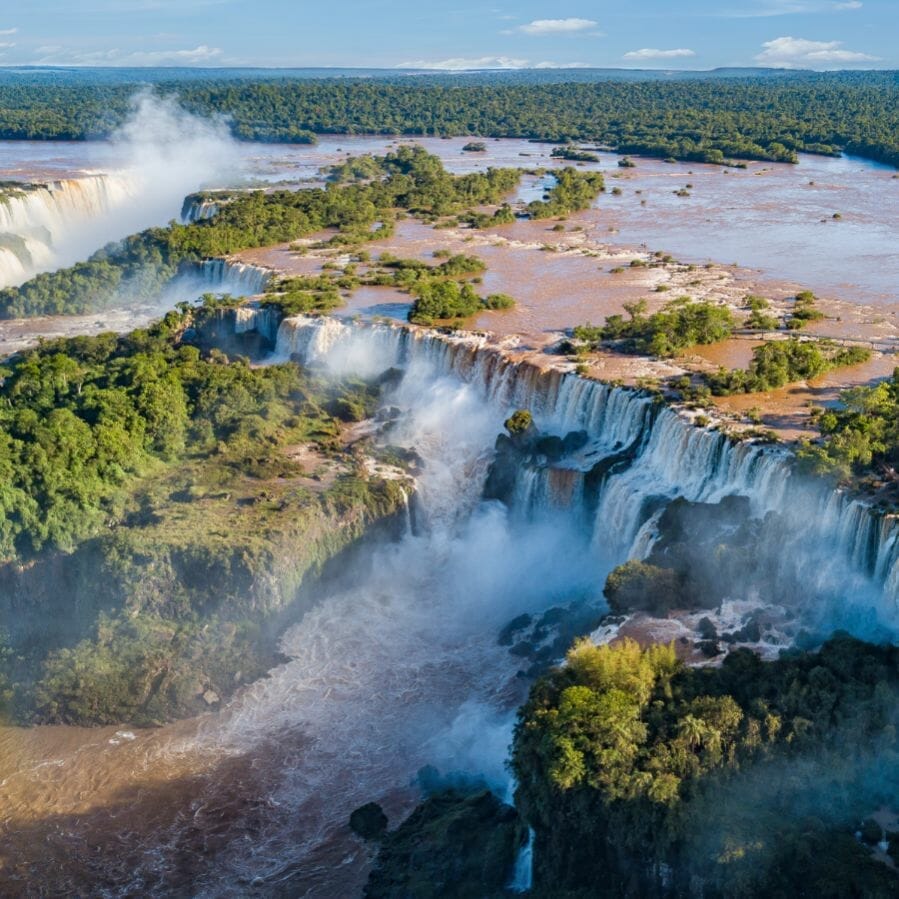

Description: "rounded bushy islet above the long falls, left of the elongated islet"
574 297 736 357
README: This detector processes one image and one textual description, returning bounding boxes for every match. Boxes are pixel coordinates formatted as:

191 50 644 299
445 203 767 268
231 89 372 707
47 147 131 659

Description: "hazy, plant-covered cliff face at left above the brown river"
0 468 404 724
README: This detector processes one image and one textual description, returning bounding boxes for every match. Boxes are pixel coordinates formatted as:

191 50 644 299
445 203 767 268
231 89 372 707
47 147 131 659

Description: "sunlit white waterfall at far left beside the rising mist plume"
0 175 135 287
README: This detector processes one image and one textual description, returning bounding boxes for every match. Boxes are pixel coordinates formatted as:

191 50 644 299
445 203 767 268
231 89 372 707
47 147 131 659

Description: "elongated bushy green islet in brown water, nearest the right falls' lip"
706 338 871 396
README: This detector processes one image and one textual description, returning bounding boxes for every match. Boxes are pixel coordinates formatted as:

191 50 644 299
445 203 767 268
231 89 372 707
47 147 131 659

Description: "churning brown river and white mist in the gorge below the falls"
0 326 600 897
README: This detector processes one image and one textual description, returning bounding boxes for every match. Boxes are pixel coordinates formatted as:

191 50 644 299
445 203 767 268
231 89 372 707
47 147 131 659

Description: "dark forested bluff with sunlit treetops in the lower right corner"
512 636 899 899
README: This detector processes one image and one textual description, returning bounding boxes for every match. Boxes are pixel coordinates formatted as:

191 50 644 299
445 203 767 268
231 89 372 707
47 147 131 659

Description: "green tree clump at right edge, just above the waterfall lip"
799 369 899 483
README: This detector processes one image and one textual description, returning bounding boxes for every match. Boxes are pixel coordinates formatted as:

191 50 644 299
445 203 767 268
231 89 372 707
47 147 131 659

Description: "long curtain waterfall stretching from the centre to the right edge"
276 316 899 619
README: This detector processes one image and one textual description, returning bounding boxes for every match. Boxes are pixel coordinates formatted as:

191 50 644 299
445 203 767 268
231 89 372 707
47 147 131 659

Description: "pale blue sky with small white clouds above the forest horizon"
0 0 899 70
